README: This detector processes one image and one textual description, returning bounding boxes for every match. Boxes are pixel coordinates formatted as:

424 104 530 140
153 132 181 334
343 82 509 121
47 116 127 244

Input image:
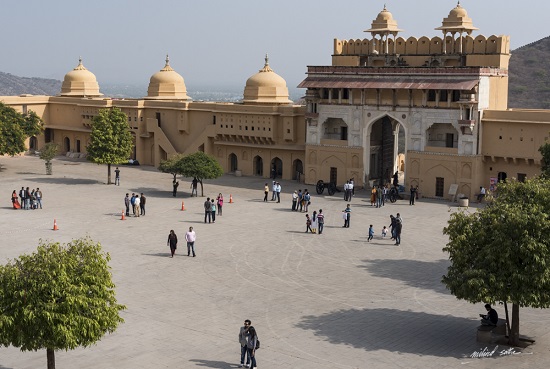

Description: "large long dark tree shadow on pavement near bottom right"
296 309 478 358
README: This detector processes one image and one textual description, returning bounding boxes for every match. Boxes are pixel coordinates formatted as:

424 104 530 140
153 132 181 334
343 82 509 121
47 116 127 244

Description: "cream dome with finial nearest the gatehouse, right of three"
243 54 292 104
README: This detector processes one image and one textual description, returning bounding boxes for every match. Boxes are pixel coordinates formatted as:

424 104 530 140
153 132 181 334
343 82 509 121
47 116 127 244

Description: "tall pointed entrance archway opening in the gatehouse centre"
367 115 406 185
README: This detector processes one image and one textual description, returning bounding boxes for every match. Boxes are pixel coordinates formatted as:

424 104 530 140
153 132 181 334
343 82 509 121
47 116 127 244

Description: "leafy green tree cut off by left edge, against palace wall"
0 102 43 156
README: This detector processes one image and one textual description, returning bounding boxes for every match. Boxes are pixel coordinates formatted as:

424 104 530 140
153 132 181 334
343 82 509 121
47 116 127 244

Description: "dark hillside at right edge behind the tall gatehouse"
508 36 550 109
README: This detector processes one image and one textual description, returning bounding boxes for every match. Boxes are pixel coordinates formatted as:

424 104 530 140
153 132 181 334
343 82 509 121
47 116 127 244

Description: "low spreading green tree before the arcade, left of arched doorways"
159 151 223 196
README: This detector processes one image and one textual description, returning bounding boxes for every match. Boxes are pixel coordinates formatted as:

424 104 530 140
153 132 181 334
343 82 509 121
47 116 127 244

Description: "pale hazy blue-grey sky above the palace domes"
0 0 550 89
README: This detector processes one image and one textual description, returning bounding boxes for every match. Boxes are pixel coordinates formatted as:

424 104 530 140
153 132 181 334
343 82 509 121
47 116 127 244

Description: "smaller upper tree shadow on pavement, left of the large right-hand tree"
359 259 449 294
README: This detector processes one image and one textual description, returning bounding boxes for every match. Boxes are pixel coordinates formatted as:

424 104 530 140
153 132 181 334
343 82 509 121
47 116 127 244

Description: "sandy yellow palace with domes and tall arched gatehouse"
0 3 550 198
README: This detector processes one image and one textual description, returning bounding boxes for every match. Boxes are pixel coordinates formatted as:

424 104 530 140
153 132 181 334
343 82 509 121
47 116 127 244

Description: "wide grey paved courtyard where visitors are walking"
0 157 550 369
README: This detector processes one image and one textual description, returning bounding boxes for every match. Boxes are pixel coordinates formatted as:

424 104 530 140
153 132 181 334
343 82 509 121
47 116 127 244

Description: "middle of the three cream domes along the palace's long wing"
146 55 190 100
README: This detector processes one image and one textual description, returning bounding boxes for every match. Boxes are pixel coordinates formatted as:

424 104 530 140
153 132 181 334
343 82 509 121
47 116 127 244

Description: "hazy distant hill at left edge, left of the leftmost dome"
0 72 61 96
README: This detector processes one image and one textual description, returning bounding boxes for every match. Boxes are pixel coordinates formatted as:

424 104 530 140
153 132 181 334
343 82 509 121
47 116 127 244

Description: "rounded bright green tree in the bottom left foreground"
0 237 126 369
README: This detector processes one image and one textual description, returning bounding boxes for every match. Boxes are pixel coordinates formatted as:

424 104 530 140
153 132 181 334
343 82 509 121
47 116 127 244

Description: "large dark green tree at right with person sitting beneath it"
442 178 550 346
